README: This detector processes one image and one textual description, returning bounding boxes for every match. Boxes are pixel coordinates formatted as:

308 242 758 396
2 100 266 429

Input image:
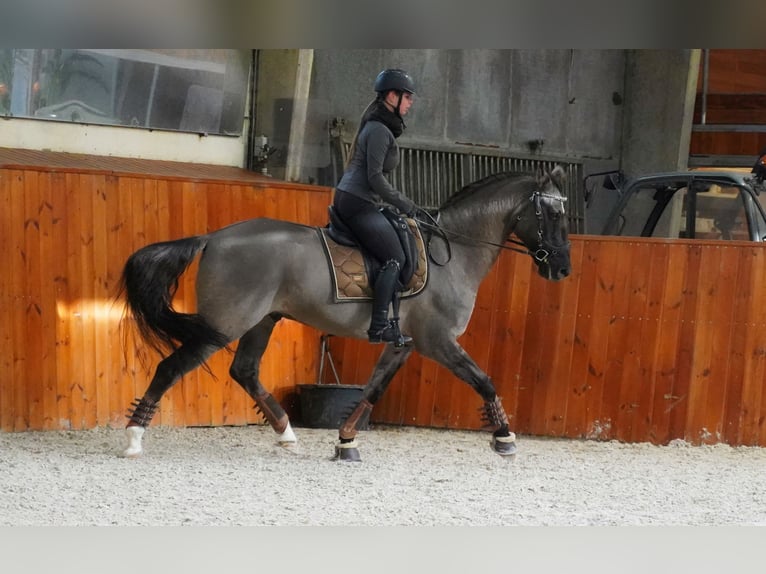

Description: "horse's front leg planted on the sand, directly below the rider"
335 345 412 462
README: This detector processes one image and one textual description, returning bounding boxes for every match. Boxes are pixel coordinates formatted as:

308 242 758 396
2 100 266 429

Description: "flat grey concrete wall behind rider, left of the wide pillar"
266 49 625 185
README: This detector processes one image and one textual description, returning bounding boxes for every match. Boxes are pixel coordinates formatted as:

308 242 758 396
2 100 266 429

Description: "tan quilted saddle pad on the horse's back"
317 218 428 303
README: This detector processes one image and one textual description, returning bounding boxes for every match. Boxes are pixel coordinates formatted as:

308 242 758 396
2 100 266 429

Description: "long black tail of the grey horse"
118 236 228 362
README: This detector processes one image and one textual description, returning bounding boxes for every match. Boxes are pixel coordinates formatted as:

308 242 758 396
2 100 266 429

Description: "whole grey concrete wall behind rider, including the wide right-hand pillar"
256 49 699 232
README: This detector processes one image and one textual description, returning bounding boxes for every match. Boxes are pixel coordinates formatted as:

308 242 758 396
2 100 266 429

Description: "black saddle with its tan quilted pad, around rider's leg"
318 205 428 303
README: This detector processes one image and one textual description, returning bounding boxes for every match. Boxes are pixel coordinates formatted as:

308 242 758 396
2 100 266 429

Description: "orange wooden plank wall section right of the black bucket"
331 236 766 446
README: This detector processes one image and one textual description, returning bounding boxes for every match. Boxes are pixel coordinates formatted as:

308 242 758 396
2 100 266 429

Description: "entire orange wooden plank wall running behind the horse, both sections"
0 160 766 446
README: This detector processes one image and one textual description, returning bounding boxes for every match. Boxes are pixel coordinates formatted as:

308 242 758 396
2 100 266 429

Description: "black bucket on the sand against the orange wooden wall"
298 384 370 430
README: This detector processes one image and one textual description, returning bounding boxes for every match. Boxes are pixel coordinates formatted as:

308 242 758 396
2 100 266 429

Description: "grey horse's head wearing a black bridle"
513 165 572 281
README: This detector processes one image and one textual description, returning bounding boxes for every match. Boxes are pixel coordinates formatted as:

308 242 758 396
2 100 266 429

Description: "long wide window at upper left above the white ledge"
0 49 251 136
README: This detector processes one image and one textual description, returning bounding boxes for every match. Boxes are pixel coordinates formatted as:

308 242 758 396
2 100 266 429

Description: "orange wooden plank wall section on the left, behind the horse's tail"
0 168 331 431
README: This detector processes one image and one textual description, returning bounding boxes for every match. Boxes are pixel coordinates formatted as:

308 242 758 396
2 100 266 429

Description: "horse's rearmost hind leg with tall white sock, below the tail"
122 345 220 458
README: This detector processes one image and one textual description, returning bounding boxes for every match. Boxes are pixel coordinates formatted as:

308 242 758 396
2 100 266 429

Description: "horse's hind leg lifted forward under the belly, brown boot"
229 315 296 444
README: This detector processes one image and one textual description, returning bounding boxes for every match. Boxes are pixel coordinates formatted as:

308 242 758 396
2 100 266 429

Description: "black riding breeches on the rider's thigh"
333 190 407 269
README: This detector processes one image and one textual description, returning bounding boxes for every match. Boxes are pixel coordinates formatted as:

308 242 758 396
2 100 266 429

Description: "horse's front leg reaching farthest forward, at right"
419 340 516 456
